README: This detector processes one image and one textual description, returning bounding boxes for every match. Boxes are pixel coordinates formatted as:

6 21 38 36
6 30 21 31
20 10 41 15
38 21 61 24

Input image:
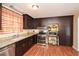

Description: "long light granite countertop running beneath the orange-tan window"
0 31 39 49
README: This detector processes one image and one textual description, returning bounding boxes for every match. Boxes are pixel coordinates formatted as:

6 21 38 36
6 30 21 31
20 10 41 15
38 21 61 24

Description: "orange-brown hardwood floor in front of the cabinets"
24 44 79 56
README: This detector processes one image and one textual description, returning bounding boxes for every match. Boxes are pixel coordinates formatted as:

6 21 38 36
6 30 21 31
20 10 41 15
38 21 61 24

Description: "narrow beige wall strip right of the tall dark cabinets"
73 15 78 50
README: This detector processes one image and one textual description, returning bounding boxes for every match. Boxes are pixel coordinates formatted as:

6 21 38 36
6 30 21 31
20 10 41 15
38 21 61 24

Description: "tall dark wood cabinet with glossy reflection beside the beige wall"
59 16 73 46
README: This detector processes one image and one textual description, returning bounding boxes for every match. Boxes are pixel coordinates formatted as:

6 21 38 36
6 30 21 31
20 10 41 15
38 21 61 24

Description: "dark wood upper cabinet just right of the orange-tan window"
23 14 34 29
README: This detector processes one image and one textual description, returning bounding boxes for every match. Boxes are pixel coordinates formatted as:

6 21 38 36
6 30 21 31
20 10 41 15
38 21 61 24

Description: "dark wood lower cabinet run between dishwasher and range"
15 35 37 56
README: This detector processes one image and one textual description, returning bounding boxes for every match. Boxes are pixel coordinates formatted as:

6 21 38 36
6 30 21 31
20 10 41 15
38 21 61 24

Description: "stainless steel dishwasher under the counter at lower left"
0 44 15 56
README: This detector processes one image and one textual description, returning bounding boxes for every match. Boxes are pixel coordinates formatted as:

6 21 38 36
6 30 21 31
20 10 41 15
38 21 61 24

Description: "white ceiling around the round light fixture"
4 3 79 18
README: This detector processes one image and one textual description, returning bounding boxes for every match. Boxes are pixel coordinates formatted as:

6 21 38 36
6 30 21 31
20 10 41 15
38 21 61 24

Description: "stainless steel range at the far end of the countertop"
37 27 48 45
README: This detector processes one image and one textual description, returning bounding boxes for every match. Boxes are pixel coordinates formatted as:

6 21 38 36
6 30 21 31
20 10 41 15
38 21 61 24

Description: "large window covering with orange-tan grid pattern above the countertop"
2 7 23 33
